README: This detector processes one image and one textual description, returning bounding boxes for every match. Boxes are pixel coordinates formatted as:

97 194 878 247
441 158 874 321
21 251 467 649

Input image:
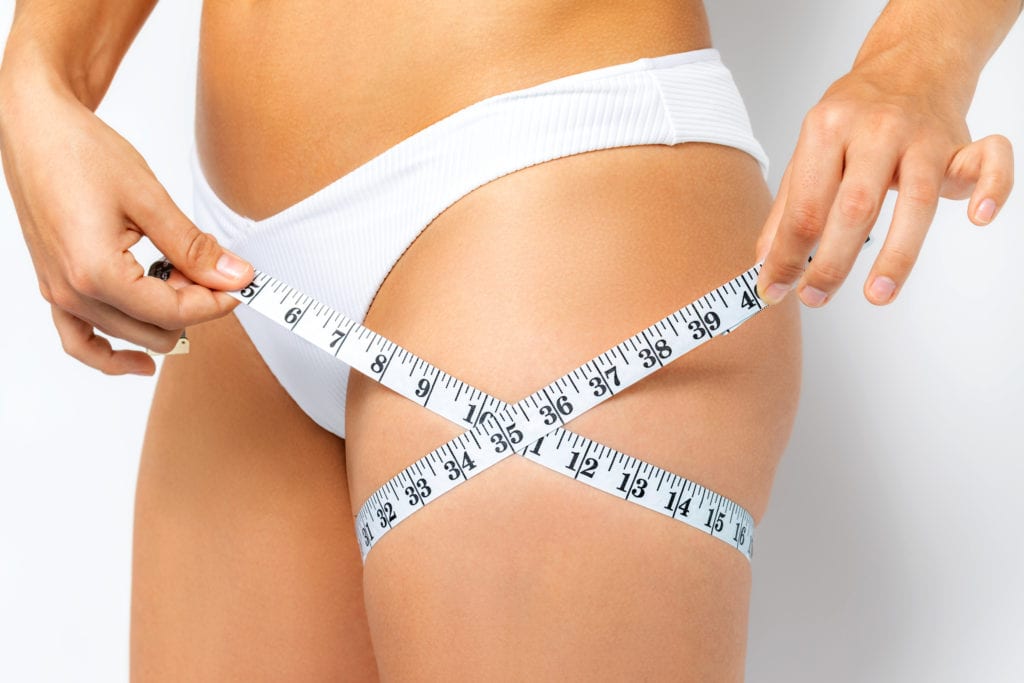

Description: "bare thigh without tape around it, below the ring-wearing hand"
131 314 377 681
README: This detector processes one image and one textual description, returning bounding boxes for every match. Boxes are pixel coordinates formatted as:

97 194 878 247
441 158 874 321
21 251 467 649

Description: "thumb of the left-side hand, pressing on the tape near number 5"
128 182 255 291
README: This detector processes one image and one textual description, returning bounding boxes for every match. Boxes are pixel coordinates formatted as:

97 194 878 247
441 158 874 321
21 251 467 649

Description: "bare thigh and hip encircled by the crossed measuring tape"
346 143 800 681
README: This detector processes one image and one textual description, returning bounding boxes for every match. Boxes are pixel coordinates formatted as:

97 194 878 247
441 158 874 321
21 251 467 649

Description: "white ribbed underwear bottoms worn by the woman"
190 48 768 438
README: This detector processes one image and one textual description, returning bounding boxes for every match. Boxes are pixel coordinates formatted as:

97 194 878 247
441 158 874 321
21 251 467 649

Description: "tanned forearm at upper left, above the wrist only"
0 0 157 110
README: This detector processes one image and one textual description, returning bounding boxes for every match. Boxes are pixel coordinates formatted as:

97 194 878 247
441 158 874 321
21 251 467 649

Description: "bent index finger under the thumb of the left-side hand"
84 246 240 330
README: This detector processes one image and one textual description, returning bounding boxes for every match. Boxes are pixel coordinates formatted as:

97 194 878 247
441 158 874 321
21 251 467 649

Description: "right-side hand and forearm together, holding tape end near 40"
758 0 1024 307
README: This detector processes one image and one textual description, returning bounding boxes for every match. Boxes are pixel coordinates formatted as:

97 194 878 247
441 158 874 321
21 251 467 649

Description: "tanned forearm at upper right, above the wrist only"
854 0 1024 114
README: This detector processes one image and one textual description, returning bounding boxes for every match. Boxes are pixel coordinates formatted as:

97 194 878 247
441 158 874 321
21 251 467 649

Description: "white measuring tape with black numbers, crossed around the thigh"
205 237 871 561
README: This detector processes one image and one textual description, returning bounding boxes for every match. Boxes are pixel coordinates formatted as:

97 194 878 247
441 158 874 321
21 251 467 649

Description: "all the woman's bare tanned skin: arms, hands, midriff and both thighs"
0 0 1020 680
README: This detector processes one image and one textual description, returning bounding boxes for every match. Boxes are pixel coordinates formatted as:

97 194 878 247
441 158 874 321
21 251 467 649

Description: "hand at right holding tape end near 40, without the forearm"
757 61 1014 306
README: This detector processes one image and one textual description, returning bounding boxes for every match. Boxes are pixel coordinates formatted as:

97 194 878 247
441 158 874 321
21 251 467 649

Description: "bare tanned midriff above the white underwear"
196 0 711 220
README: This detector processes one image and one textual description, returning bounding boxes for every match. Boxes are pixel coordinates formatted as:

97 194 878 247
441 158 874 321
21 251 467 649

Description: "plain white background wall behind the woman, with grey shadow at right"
0 0 1024 683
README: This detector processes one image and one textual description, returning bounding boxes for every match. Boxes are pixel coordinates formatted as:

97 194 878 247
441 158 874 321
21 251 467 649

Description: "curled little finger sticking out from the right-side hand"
942 135 1014 225
